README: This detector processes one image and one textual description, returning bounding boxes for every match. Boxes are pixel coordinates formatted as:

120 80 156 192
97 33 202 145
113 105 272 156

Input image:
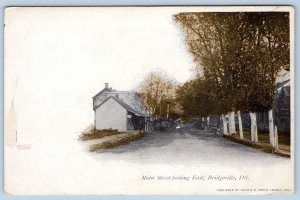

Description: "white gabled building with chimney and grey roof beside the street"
93 83 148 131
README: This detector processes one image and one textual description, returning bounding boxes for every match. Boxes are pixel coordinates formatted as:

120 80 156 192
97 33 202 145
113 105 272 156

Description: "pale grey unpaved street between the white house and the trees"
95 128 290 167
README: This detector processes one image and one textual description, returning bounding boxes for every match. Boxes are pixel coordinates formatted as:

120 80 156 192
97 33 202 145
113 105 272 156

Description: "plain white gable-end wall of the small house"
95 98 127 131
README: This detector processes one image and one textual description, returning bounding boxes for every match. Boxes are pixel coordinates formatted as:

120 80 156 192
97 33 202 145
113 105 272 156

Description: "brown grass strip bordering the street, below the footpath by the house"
89 133 145 152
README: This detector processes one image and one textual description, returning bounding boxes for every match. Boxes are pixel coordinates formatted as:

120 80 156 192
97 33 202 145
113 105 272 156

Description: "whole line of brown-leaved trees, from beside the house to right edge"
141 12 290 147
